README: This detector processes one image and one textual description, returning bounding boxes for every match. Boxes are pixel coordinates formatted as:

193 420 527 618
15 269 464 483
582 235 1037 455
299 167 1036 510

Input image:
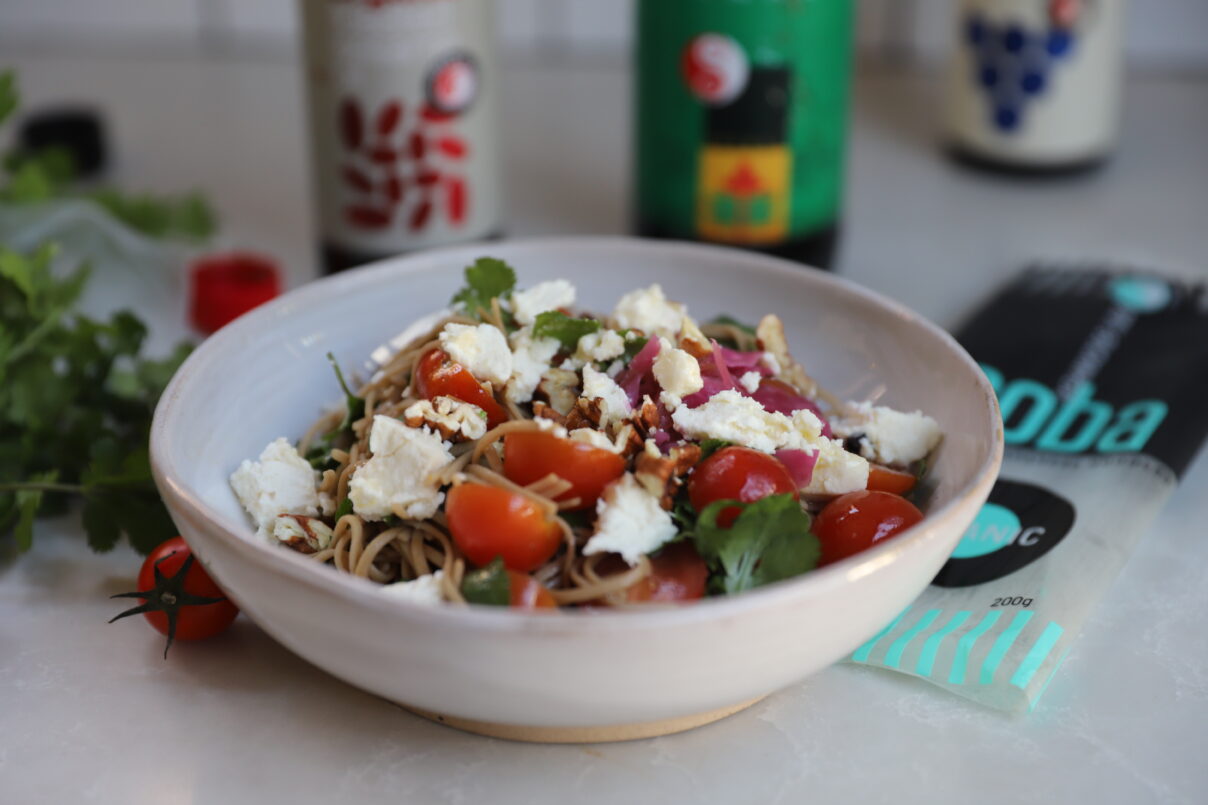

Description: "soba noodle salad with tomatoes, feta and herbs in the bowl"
231 257 941 609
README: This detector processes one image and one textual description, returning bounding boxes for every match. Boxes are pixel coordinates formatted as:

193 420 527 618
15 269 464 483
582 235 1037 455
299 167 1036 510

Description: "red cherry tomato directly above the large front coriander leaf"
687 447 797 528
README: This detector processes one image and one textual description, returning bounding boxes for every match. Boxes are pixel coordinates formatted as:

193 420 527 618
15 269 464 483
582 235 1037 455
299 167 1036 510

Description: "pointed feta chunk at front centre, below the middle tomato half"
583 473 679 566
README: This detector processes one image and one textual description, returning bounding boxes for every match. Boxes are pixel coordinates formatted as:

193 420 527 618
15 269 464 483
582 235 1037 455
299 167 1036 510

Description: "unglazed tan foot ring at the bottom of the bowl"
399 696 765 743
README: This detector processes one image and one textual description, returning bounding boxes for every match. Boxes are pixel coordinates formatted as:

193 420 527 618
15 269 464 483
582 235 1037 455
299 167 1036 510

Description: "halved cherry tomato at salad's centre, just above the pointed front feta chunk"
504 430 625 510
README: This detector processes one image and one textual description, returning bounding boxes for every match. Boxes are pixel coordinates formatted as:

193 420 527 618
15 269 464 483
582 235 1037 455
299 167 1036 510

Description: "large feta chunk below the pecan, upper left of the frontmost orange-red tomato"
348 415 453 520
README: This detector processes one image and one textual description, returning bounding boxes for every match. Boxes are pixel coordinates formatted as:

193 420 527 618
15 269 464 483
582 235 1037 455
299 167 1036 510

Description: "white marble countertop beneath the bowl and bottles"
0 56 1208 805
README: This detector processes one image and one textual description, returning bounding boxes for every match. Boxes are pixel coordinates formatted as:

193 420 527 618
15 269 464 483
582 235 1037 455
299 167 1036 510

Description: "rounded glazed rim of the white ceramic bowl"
150 236 1004 632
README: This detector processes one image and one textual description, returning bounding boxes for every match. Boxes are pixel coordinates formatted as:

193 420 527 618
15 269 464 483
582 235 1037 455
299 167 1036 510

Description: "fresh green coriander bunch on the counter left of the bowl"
0 71 202 554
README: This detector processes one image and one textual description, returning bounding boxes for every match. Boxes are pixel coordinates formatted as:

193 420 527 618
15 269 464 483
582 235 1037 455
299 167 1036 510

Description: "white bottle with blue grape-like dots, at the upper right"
947 0 1125 172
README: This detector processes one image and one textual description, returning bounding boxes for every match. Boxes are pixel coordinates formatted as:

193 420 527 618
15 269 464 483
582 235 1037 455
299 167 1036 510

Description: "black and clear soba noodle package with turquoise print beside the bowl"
850 266 1208 712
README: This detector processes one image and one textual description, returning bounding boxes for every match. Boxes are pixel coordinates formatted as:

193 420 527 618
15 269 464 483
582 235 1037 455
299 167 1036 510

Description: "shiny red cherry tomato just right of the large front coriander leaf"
811 490 923 564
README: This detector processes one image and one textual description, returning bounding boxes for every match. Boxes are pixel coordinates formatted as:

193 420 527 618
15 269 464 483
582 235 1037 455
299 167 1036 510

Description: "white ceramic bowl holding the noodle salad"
151 238 1003 737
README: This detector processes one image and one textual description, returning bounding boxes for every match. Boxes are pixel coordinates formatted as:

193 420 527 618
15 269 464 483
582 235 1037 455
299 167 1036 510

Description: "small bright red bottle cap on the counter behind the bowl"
188 251 281 335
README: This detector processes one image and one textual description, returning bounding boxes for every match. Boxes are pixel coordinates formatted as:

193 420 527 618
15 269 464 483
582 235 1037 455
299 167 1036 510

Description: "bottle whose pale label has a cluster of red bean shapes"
302 0 501 273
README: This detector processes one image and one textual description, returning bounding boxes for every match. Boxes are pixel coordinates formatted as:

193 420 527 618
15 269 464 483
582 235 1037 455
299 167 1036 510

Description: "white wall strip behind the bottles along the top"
0 0 1208 70
